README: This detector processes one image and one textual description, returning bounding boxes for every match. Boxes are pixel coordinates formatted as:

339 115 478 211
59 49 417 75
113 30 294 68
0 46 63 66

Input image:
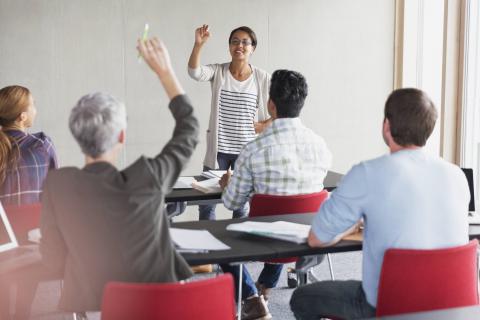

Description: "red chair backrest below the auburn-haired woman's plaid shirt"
4 203 42 244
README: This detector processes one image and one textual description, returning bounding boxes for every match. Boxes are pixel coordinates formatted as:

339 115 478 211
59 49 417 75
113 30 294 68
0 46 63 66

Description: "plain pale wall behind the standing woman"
0 0 394 174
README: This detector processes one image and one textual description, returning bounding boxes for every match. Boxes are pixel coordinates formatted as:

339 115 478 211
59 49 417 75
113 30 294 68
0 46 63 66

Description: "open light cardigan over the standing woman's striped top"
188 62 270 169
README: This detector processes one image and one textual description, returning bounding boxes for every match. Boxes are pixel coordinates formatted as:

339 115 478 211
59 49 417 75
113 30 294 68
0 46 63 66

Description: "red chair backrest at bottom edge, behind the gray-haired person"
102 274 235 320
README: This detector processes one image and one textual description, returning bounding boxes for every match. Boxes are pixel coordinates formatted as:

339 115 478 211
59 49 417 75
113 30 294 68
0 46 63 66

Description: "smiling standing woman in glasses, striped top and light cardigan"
188 25 271 220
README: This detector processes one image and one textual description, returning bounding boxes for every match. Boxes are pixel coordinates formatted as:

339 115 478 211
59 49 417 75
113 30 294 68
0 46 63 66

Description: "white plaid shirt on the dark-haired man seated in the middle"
222 118 332 210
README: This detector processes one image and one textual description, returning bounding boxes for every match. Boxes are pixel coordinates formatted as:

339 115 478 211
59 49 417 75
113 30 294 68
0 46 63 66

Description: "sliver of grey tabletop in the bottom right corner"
364 306 480 320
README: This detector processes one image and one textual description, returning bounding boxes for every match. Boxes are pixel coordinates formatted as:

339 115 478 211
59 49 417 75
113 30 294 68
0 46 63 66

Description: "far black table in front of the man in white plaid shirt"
165 171 343 203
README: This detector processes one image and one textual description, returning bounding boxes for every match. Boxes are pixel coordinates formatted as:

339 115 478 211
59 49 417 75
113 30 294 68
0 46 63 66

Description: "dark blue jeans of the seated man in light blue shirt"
290 280 376 320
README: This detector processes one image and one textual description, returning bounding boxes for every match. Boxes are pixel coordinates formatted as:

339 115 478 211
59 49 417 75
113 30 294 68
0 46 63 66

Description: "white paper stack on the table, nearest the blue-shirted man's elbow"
227 221 310 243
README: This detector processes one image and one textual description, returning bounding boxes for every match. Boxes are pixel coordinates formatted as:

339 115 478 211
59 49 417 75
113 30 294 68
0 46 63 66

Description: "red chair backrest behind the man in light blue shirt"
377 240 478 316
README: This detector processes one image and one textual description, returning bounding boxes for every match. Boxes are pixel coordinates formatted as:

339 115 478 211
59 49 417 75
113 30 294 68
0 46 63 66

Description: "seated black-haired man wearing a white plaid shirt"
220 70 332 316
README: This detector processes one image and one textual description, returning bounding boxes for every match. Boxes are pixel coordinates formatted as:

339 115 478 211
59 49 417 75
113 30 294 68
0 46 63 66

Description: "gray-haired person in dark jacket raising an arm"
40 38 198 312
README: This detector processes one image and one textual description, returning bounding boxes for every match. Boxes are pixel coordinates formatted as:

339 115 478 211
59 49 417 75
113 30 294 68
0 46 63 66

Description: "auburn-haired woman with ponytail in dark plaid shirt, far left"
0 85 57 205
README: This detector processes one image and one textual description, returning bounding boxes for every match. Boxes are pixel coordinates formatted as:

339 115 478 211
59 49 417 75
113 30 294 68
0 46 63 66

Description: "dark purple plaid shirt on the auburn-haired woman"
0 130 58 205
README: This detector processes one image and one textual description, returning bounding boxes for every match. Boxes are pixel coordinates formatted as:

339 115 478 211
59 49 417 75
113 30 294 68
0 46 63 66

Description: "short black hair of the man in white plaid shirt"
270 70 308 118
